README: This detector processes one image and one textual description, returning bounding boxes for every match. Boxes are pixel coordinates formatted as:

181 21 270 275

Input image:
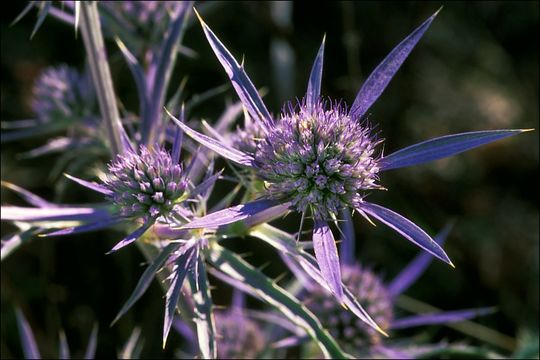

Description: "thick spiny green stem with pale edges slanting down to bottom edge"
206 244 347 359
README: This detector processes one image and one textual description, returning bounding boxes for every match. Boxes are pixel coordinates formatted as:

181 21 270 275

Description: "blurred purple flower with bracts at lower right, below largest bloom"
297 226 493 358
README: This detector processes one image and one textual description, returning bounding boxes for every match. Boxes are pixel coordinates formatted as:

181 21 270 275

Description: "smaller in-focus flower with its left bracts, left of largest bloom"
43 145 194 252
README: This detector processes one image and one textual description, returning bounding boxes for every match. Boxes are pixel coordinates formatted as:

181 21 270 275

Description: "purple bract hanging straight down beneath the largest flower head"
313 220 343 302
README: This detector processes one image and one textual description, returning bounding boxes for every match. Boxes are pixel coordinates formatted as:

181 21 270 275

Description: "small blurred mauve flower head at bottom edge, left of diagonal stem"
215 310 266 359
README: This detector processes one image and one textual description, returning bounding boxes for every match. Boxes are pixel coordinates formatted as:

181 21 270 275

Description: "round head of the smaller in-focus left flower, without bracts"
104 146 187 220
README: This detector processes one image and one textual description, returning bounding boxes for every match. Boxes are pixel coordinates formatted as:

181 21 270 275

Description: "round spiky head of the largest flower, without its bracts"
254 101 380 220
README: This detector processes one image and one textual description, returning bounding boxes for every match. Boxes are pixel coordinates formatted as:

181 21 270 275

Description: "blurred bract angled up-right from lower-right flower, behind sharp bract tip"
387 224 452 297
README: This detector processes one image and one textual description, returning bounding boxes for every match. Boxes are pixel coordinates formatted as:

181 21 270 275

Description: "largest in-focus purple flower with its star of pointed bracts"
169 9 524 299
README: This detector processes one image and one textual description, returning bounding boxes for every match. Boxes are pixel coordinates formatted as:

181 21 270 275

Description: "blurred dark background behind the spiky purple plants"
0 1 539 358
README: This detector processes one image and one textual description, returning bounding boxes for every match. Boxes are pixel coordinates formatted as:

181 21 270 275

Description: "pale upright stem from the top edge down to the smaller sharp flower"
80 1 123 157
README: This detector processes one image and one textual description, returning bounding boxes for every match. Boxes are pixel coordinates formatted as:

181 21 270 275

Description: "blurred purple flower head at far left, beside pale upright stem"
31 65 96 122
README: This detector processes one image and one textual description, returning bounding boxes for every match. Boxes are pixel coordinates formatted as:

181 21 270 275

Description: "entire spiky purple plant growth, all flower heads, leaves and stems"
2 1 523 358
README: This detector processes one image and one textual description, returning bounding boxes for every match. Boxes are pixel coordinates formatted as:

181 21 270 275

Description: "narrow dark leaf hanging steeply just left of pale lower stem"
163 245 198 348
